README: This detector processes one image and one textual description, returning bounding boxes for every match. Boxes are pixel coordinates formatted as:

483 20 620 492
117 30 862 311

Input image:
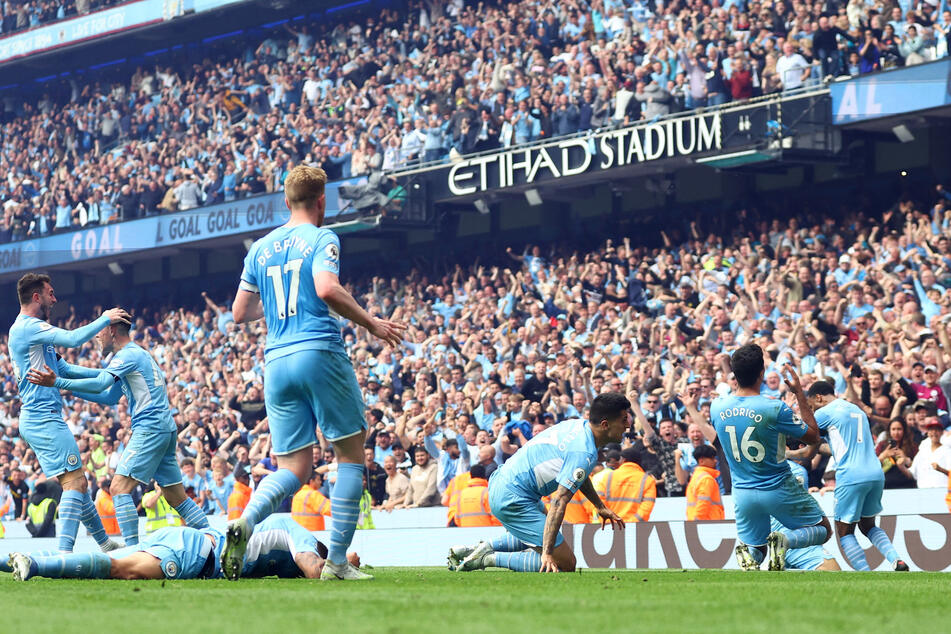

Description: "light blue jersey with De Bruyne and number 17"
239 224 343 361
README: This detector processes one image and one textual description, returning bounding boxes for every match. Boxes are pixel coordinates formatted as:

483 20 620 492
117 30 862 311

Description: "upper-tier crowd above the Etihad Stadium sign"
7 0 951 242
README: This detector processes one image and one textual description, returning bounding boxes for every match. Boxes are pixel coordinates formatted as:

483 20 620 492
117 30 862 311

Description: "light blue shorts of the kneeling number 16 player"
733 474 823 546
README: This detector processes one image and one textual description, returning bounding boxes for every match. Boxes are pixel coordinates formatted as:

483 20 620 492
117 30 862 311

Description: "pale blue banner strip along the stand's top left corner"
0 0 244 62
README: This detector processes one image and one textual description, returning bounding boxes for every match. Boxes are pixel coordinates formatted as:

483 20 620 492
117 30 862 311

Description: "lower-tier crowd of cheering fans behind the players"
0 177 951 516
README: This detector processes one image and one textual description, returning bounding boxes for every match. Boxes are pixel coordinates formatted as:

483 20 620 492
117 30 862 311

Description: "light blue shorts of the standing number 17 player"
264 350 367 456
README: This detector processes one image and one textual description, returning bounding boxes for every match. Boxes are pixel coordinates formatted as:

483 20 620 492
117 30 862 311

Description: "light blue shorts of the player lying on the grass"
138 526 225 579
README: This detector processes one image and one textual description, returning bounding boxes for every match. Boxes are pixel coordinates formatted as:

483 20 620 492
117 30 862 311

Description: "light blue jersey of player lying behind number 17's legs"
241 515 327 578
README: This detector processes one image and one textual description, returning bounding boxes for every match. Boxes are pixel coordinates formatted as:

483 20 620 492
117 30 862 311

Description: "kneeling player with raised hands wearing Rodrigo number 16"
710 344 832 570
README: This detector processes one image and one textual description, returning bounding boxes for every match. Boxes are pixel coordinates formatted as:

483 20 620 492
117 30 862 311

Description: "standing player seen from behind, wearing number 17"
222 165 405 580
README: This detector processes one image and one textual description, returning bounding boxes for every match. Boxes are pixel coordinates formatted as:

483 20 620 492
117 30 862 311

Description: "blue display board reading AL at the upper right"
829 58 951 124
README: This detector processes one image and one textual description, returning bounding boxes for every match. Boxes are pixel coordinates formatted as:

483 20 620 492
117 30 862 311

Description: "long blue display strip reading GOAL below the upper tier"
0 178 366 275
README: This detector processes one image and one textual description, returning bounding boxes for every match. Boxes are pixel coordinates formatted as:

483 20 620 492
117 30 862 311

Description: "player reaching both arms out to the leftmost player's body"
27 323 208 546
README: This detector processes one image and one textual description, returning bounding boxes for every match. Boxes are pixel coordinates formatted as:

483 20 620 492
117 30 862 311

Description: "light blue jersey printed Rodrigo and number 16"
710 396 809 489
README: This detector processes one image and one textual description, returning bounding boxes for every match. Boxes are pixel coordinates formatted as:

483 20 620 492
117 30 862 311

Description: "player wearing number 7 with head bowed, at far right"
808 381 908 571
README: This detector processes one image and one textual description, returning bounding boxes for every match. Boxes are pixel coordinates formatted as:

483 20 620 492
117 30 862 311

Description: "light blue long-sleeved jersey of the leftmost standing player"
8 313 109 416
